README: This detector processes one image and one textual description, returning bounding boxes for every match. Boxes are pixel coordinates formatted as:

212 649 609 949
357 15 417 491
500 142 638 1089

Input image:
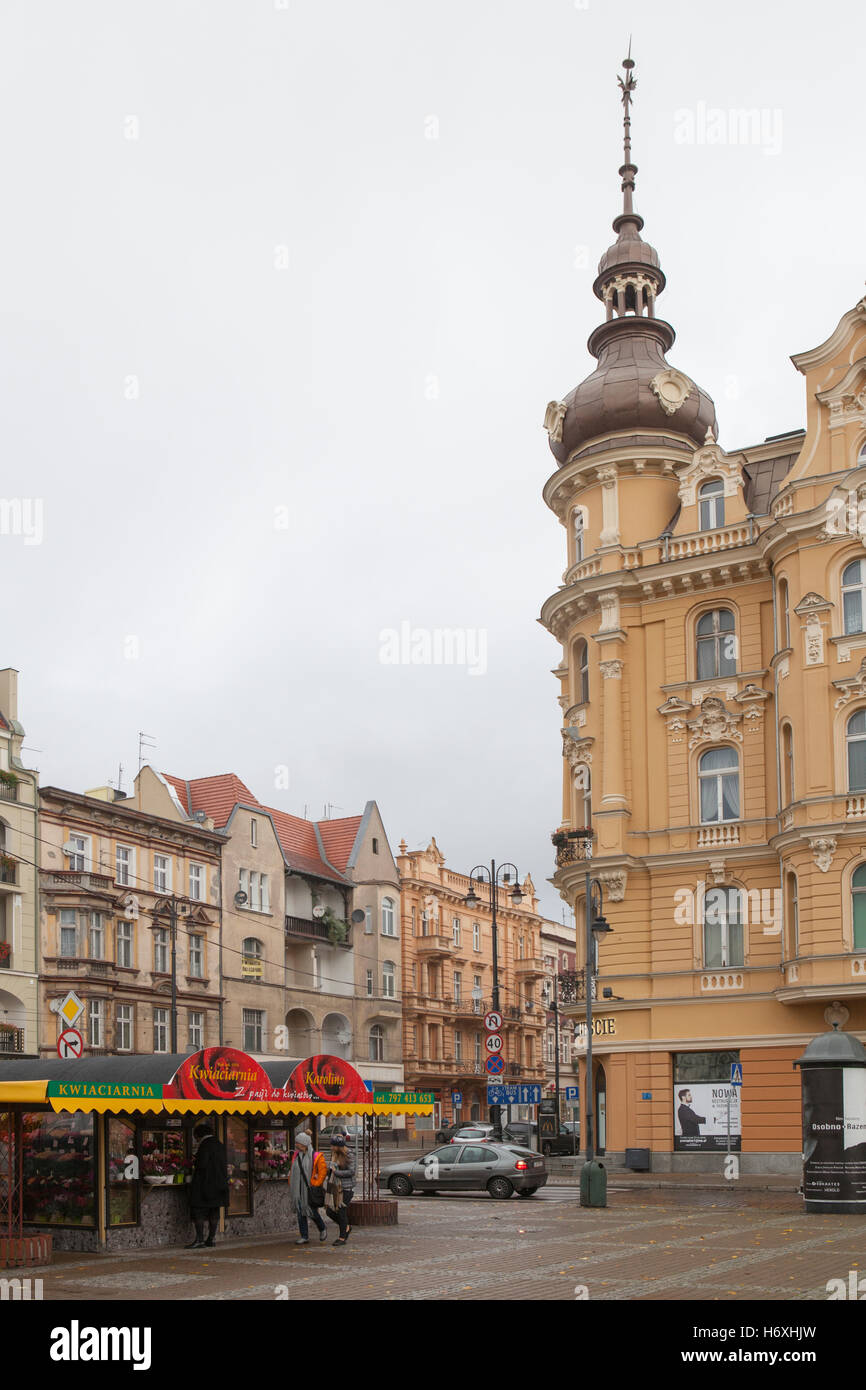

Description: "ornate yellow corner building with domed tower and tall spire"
542 63 866 1172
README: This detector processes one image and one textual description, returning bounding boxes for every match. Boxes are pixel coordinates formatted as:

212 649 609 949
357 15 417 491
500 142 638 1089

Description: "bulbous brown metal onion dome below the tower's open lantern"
550 316 717 464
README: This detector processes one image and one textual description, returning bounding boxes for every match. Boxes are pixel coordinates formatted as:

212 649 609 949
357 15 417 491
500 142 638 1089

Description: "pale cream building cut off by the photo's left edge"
0 667 39 1056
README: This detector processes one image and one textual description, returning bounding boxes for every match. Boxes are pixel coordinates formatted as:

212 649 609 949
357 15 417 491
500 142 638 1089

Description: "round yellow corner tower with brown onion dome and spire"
541 57 717 901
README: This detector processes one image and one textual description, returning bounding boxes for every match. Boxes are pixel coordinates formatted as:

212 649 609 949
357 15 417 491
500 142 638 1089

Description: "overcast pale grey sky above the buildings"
0 0 866 917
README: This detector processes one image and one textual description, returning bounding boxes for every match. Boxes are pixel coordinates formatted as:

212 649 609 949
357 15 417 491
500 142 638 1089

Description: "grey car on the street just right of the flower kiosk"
379 1141 548 1201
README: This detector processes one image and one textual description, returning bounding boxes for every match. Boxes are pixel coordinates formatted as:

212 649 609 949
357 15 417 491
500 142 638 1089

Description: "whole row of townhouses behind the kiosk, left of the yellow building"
0 670 572 1122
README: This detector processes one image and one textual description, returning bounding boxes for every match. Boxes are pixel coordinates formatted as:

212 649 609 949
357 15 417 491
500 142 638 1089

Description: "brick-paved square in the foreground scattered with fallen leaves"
18 1186 866 1302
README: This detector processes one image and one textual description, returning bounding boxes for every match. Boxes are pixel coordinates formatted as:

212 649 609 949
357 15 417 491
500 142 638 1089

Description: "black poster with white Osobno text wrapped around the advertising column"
803 1066 866 1202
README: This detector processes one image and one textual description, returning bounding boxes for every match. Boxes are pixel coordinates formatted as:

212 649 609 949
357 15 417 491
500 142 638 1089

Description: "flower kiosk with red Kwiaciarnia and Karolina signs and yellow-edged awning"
0 1047 432 1268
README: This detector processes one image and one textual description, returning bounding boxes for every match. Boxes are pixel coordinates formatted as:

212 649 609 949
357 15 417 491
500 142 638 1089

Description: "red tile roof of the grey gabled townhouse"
163 773 354 883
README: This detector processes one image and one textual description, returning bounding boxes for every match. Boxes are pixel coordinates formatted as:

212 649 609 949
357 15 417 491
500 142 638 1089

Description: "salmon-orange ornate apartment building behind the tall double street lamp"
398 840 545 1127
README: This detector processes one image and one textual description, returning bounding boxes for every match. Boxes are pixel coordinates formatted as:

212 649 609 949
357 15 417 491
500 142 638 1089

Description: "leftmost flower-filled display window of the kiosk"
22 1111 96 1226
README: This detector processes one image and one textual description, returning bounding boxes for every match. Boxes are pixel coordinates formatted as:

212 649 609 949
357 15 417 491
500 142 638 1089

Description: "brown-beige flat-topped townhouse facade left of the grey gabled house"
39 787 224 1056
